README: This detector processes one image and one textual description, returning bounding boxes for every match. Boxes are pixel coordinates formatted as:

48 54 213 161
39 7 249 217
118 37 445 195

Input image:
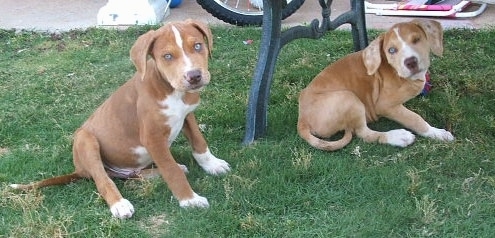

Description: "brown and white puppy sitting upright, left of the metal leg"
11 20 230 218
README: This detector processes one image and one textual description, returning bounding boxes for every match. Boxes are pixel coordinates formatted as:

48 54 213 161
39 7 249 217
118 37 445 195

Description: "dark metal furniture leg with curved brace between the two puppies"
243 0 368 144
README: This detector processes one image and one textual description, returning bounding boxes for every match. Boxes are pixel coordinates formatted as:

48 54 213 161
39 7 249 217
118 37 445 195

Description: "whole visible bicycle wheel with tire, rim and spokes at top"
196 0 305 26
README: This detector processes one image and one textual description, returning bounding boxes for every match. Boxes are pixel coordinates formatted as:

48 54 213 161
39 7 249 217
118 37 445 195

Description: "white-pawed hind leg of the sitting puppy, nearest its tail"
73 129 134 218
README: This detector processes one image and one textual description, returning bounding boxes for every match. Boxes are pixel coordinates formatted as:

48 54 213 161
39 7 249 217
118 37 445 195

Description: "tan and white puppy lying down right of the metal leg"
297 20 454 151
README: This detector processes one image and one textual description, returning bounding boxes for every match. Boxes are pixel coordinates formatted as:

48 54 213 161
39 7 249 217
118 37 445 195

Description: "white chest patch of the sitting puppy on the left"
158 91 198 146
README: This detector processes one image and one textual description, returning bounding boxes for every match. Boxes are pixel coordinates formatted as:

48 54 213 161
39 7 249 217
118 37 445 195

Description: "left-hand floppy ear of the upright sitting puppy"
130 30 157 80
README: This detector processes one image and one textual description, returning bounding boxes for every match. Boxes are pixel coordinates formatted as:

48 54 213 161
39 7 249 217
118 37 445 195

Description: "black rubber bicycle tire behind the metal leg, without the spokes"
196 0 305 26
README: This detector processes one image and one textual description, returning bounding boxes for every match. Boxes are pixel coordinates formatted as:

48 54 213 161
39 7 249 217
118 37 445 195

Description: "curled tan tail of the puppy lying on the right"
297 120 352 151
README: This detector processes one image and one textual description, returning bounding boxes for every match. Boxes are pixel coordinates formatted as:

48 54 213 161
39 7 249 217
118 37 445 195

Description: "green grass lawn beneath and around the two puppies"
0 23 495 237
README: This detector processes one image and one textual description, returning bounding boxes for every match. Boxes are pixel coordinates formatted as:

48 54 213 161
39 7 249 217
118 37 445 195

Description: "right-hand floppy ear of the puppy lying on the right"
411 19 443 56
